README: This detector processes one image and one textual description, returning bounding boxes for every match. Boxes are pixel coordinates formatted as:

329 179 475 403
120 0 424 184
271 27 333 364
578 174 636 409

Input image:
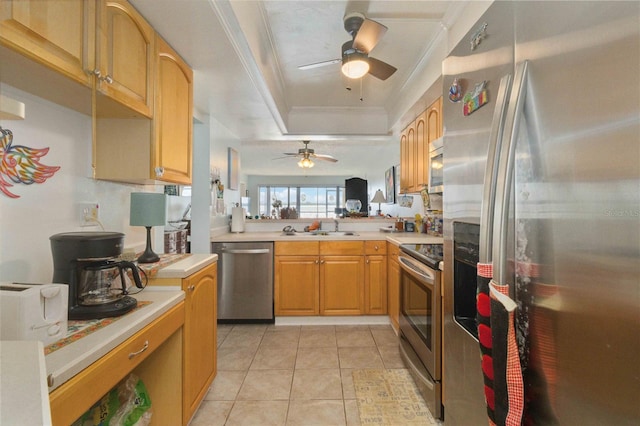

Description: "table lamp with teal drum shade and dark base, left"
129 192 167 263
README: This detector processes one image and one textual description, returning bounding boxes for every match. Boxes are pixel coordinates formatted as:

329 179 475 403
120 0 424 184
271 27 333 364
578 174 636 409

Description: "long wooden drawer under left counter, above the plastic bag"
49 302 184 425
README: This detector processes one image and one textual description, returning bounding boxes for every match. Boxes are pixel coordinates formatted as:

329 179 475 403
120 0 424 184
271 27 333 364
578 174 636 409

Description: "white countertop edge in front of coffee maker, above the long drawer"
44 287 184 392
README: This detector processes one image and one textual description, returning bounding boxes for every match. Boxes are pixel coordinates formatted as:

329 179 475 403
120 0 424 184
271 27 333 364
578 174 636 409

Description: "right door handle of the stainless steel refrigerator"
492 61 529 285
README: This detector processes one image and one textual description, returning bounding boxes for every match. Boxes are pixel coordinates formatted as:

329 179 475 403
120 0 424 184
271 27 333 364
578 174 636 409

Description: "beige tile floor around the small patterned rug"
191 325 430 426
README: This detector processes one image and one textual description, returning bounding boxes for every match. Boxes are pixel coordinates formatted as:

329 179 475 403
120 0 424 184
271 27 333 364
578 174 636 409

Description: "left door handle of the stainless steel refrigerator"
478 74 511 263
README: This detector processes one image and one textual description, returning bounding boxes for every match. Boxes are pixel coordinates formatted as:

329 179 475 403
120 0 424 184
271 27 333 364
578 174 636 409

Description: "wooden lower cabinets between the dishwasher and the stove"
274 240 387 316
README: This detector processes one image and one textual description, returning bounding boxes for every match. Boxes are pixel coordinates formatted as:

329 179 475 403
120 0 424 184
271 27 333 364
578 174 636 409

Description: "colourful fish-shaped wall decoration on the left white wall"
0 127 60 198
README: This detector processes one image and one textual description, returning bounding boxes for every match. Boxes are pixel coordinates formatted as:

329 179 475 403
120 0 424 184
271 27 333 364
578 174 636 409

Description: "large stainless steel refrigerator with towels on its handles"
443 1 640 425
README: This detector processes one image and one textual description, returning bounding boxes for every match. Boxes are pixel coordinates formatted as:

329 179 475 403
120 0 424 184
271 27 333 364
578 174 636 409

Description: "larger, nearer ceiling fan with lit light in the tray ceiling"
298 12 397 80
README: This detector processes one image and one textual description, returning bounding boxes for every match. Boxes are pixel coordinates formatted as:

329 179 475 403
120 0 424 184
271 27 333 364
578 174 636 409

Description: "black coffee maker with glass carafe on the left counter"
49 232 143 320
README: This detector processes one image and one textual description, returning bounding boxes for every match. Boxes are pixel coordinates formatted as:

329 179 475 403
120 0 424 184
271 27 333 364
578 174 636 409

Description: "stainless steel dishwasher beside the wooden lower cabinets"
211 242 274 323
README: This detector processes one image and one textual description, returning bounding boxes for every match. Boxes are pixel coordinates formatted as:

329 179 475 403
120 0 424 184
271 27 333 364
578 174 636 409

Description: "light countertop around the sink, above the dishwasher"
211 231 442 244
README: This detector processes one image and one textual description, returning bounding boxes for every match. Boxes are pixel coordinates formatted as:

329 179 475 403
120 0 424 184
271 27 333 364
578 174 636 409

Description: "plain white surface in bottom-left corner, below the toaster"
0 340 51 425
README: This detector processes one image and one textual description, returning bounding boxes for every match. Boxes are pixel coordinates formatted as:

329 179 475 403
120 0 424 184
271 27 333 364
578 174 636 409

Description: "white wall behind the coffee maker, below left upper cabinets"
0 84 164 282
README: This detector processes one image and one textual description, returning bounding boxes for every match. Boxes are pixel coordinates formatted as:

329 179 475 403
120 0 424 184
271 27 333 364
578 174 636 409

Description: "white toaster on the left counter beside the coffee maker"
0 283 69 345
